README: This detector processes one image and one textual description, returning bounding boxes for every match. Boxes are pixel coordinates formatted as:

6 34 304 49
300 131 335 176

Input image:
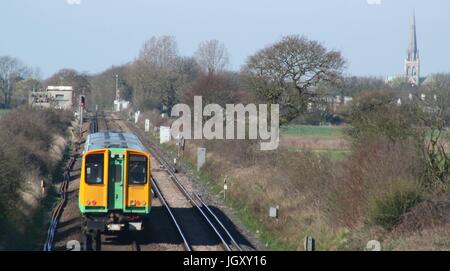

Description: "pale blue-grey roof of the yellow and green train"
84 131 146 152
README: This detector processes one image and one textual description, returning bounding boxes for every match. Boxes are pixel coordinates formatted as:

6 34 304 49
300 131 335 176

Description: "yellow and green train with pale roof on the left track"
79 132 151 234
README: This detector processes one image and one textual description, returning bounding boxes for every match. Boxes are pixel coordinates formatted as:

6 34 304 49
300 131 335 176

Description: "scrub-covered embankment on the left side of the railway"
0 109 71 250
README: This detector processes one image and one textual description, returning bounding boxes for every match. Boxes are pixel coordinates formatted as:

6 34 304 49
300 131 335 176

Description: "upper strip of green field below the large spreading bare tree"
280 125 344 139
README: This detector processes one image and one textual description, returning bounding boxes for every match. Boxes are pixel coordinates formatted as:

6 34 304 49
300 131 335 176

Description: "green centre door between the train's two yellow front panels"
108 156 123 209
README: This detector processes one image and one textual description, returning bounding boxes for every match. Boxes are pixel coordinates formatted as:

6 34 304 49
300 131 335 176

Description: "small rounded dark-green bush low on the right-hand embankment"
369 180 422 230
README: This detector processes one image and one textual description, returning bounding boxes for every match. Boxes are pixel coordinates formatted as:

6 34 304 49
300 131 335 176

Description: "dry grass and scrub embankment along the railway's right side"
139 97 450 250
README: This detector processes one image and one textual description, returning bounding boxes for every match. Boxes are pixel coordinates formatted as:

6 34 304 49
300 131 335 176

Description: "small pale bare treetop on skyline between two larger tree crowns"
194 40 229 73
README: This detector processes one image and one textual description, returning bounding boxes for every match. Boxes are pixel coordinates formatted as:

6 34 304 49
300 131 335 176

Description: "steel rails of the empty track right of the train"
107 112 242 251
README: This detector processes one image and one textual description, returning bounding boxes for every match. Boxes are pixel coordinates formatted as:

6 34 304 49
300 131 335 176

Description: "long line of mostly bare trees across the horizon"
0 35 450 124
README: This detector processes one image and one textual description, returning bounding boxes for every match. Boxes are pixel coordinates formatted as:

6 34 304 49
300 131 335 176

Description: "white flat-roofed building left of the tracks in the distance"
28 86 73 110
